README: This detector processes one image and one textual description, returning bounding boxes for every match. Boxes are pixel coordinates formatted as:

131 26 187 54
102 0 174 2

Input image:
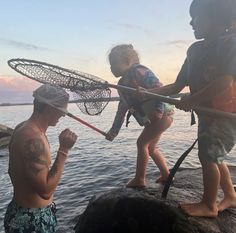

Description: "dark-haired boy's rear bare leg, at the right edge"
218 162 236 211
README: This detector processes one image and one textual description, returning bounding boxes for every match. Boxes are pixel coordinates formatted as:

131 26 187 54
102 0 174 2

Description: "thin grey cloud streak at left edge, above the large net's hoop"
0 38 49 51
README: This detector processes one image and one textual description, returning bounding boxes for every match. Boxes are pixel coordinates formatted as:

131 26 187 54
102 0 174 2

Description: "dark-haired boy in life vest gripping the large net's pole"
152 0 236 217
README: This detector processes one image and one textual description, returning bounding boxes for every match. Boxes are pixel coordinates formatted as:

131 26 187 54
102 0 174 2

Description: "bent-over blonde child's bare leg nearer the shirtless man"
126 128 150 187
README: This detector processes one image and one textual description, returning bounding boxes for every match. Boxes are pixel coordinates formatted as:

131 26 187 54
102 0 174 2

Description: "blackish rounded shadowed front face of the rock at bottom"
76 189 199 233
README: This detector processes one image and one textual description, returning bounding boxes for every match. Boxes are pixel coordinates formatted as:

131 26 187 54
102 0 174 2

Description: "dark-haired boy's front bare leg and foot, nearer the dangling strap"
180 158 220 217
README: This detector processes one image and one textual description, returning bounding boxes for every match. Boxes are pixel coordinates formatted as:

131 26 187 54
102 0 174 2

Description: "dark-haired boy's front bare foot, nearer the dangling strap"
180 202 218 218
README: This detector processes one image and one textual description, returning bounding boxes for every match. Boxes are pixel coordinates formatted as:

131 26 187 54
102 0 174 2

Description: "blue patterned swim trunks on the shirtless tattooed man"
4 201 57 233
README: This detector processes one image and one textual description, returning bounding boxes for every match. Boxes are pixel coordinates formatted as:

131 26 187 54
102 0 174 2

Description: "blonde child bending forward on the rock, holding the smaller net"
106 44 173 187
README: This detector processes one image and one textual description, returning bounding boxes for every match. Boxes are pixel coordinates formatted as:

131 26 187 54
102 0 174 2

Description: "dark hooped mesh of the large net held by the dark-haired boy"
8 58 111 115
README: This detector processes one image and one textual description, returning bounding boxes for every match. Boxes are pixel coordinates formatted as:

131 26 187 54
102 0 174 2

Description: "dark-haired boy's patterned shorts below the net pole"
198 116 236 164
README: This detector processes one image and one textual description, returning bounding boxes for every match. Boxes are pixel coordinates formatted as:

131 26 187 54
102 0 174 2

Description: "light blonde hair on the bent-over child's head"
108 44 139 63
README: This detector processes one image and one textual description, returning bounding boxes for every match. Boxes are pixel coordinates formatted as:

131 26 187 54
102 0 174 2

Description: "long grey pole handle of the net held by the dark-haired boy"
107 83 236 119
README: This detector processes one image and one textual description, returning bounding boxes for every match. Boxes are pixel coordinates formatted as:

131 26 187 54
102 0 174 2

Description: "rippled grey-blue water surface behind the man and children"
0 102 236 233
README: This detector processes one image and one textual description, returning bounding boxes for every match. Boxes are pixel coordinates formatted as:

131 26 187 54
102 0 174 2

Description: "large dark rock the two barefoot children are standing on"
75 167 236 233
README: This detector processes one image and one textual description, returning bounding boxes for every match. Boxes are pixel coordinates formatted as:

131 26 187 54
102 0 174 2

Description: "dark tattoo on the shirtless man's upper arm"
24 138 48 175
